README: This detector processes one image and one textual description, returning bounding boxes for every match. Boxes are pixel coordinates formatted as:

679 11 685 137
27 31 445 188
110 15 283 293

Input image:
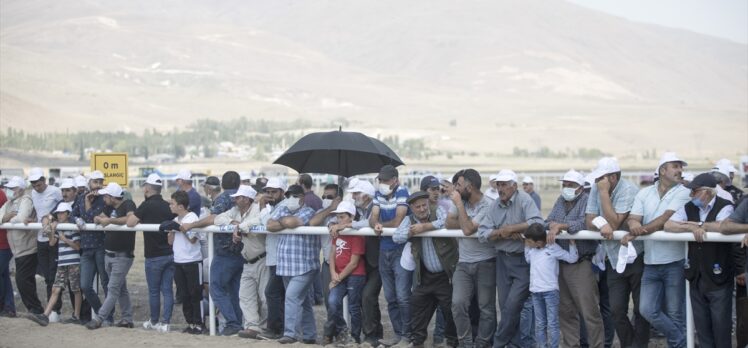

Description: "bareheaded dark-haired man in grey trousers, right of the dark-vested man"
447 169 496 347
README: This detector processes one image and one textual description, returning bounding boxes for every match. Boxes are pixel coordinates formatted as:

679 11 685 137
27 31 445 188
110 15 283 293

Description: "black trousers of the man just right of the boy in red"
361 260 384 339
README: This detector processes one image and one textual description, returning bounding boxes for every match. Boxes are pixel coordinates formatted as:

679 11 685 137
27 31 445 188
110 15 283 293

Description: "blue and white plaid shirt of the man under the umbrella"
270 206 321 277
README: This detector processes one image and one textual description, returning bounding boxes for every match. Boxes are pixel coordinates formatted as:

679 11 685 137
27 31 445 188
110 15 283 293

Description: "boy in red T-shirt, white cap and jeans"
324 201 366 344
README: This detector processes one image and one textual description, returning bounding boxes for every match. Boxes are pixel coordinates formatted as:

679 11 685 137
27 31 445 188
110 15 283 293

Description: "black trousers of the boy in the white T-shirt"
174 261 203 325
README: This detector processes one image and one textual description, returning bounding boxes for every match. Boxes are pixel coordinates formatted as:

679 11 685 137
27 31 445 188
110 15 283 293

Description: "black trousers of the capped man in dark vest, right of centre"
410 266 457 347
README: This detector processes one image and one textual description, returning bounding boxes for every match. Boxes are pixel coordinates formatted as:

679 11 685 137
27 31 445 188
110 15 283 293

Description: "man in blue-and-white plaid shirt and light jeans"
266 185 321 344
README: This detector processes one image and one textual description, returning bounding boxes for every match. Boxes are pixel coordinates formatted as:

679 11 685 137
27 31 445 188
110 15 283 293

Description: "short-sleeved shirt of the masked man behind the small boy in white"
545 192 599 259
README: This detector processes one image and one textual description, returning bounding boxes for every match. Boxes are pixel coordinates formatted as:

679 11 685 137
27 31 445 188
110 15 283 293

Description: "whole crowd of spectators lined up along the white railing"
0 153 748 347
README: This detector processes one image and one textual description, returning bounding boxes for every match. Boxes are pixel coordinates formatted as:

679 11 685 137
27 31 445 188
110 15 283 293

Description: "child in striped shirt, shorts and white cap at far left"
29 202 82 326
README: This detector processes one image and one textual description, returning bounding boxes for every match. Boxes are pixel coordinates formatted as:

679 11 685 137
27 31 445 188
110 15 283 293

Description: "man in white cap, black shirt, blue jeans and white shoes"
127 173 175 332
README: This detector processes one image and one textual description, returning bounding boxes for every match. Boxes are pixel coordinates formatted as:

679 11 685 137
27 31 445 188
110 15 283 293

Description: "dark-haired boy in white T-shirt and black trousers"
162 191 204 335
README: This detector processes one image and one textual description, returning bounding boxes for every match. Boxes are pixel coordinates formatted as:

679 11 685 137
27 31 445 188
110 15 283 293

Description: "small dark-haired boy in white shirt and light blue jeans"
525 223 579 348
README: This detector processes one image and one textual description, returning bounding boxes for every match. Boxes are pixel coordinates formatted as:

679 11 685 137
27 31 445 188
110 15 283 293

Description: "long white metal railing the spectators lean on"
0 223 743 348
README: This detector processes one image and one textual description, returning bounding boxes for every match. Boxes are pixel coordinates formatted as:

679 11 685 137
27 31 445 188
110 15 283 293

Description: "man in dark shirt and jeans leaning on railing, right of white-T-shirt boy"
179 171 244 336
